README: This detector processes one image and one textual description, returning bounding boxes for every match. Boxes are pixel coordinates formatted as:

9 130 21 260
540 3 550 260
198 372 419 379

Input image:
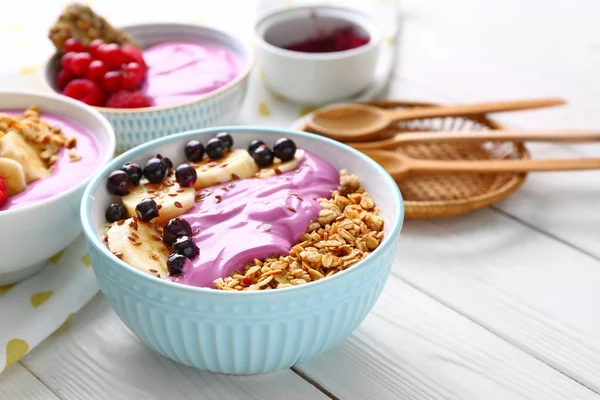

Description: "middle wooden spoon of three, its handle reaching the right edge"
346 130 600 150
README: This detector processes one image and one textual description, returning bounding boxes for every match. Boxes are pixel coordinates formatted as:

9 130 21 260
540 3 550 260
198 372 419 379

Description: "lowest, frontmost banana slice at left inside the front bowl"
106 218 169 278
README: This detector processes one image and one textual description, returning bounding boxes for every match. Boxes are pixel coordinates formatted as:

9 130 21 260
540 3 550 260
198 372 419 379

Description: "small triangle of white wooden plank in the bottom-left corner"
0 363 58 400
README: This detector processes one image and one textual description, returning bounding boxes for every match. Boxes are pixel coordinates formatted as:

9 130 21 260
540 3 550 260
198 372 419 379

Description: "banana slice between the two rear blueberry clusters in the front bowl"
196 149 258 189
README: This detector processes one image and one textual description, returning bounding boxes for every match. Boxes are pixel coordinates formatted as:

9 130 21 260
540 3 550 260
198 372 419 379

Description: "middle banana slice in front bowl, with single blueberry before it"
122 177 196 225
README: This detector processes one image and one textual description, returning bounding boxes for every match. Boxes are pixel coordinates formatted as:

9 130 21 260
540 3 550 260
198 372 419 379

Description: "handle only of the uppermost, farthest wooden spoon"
386 98 565 121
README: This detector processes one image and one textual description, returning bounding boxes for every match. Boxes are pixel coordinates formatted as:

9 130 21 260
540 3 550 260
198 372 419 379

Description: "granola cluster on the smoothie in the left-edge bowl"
0 106 81 171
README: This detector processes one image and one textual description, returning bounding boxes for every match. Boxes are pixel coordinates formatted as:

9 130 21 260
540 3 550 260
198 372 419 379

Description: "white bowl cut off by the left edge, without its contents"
0 90 115 286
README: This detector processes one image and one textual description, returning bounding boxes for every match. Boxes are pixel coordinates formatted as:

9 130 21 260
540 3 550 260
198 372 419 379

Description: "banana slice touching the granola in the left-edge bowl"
0 131 50 183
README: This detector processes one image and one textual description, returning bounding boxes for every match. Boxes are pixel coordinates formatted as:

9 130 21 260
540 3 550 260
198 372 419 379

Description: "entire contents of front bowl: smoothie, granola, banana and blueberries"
104 132 384 291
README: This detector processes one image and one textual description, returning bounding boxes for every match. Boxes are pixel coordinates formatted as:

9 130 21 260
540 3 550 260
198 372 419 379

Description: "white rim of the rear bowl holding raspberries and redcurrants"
41 22 255 114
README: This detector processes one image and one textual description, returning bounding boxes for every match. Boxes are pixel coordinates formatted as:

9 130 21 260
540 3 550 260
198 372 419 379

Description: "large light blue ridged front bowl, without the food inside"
81 127 404 374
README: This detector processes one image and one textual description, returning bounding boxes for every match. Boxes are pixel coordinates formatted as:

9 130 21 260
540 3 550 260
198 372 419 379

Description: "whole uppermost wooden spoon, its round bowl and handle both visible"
307 98 565 142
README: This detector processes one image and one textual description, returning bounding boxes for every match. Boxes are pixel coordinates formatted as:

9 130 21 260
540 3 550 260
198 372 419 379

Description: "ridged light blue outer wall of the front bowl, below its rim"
90 236 396 374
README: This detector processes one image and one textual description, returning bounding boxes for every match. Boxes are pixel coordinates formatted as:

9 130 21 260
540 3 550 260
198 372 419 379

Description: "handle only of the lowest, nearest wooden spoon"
406 158 600 173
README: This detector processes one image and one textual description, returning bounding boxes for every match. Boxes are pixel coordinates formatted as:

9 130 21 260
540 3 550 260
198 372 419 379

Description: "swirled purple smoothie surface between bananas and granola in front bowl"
175 151 339 287
